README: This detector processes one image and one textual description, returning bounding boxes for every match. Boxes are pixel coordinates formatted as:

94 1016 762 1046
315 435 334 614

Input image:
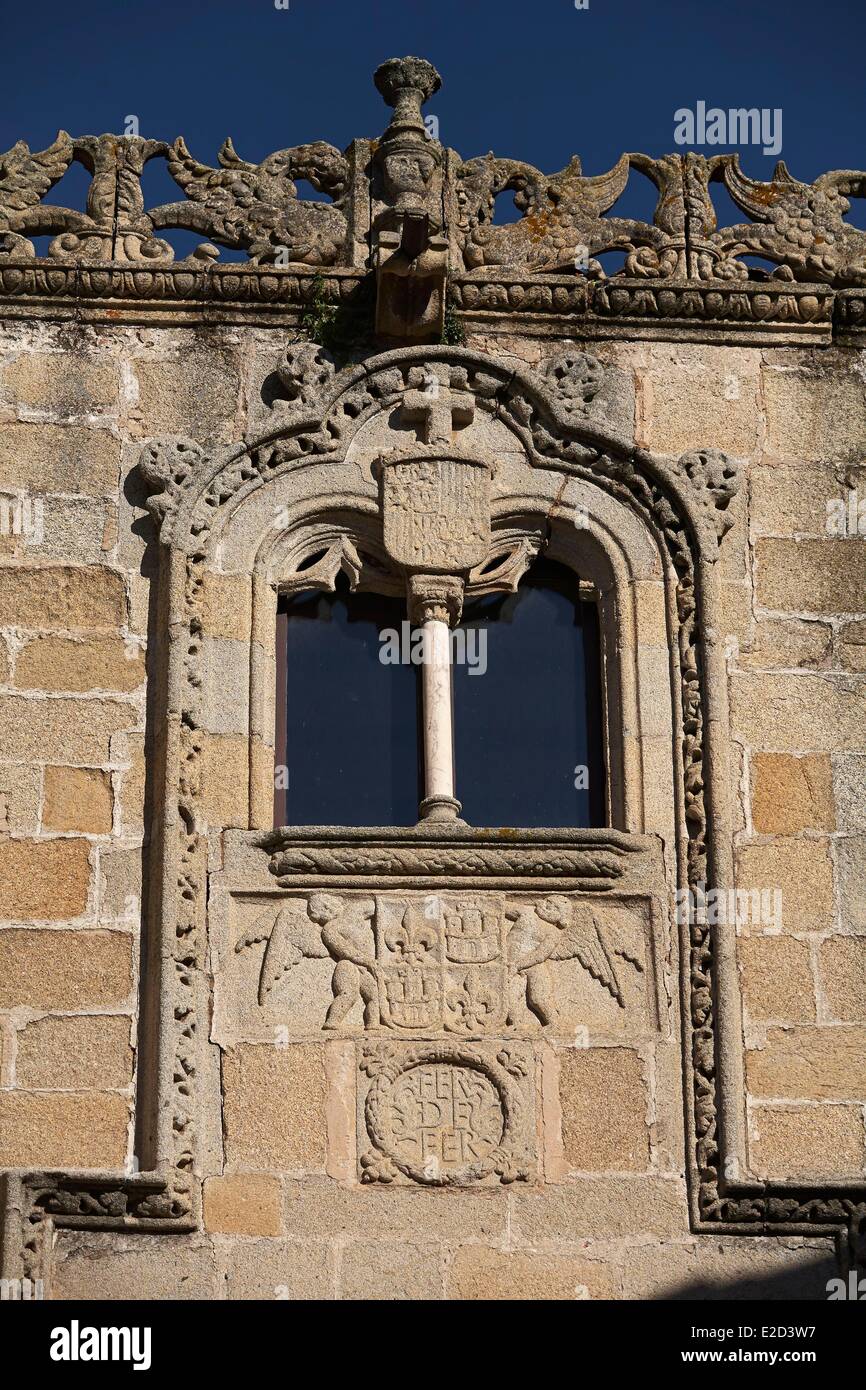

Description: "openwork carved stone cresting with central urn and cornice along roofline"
0 57 866 342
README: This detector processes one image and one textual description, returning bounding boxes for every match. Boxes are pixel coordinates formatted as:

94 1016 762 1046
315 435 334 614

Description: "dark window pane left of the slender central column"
274 574 423 826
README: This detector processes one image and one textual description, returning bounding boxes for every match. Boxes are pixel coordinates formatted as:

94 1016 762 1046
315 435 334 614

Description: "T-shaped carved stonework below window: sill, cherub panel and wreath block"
210 827 671 1186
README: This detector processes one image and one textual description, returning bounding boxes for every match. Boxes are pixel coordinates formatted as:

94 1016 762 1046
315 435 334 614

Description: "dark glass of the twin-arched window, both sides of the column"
274 559 607 828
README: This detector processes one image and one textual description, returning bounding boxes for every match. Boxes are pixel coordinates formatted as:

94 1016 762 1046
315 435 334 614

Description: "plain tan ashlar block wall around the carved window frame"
0 321 866 1298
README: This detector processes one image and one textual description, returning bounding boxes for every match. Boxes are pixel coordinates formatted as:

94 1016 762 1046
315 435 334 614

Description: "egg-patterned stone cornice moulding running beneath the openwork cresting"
0 259 866 346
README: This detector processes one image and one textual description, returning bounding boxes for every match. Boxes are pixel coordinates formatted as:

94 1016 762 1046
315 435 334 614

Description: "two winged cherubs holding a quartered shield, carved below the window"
235 892 644 1034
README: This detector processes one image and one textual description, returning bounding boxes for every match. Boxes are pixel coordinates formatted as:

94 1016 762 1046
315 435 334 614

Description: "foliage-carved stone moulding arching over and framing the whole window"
7 341 866 1272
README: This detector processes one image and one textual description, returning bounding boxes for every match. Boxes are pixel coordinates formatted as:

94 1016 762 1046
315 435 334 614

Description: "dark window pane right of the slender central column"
453 559 606 827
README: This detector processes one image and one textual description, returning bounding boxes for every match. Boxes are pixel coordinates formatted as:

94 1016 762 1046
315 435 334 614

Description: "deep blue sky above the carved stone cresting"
0 0 866 222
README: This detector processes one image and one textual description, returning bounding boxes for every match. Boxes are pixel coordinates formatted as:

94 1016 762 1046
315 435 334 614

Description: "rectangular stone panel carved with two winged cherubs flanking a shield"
215 888 659 1041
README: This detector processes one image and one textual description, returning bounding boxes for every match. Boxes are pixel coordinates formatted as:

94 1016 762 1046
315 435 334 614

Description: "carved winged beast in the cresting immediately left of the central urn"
149 136 349 265
